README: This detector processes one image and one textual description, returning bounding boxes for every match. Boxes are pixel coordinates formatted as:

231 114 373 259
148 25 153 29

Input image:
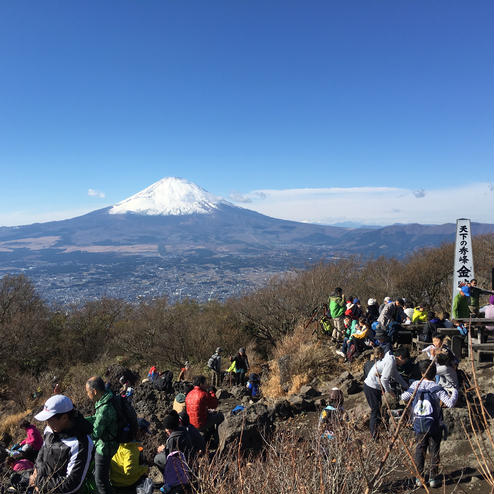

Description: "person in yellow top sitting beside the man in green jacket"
110 418 149 488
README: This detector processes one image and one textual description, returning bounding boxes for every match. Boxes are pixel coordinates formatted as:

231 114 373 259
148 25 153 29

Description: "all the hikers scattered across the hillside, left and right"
1 280 494 494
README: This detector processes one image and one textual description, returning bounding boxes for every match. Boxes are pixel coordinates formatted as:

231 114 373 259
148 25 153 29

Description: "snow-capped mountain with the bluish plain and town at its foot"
0 178 494 302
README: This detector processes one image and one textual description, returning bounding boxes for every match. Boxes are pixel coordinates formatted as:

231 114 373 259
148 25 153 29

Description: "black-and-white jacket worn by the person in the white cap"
36 415 93 494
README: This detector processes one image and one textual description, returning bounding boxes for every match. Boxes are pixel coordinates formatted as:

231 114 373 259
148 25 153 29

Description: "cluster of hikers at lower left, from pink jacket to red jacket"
0 375 224 494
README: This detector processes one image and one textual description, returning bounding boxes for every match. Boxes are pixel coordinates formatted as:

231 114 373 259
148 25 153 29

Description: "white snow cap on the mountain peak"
109 177 228 216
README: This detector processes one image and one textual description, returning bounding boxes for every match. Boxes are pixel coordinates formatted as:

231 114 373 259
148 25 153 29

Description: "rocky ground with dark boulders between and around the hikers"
0 361 494 494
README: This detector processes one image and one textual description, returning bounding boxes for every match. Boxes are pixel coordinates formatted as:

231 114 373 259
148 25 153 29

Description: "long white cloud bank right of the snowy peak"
230 183 494 225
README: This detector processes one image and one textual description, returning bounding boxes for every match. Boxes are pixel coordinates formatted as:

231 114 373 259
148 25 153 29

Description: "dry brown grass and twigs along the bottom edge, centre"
193 424 410 494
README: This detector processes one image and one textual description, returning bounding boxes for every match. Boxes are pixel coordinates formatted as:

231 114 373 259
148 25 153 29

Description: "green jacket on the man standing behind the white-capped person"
87 391 118 457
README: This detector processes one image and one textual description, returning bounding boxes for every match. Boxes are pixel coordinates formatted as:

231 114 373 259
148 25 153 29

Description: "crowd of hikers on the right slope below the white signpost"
319 280 494 487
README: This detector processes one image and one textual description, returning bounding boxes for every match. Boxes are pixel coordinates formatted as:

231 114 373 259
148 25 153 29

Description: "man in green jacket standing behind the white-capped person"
86 376 119 494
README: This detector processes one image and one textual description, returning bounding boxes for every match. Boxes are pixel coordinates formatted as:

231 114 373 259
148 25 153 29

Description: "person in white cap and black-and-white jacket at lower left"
29 395 93 494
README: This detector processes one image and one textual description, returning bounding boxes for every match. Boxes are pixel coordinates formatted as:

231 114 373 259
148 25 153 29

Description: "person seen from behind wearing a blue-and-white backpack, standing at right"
401 360 458 488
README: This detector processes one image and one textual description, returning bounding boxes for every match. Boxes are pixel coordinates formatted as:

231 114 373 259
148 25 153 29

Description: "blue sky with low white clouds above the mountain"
0 0 494 225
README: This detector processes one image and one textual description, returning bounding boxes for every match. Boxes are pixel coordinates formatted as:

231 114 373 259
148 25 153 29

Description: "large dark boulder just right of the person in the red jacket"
218 403 273 451
